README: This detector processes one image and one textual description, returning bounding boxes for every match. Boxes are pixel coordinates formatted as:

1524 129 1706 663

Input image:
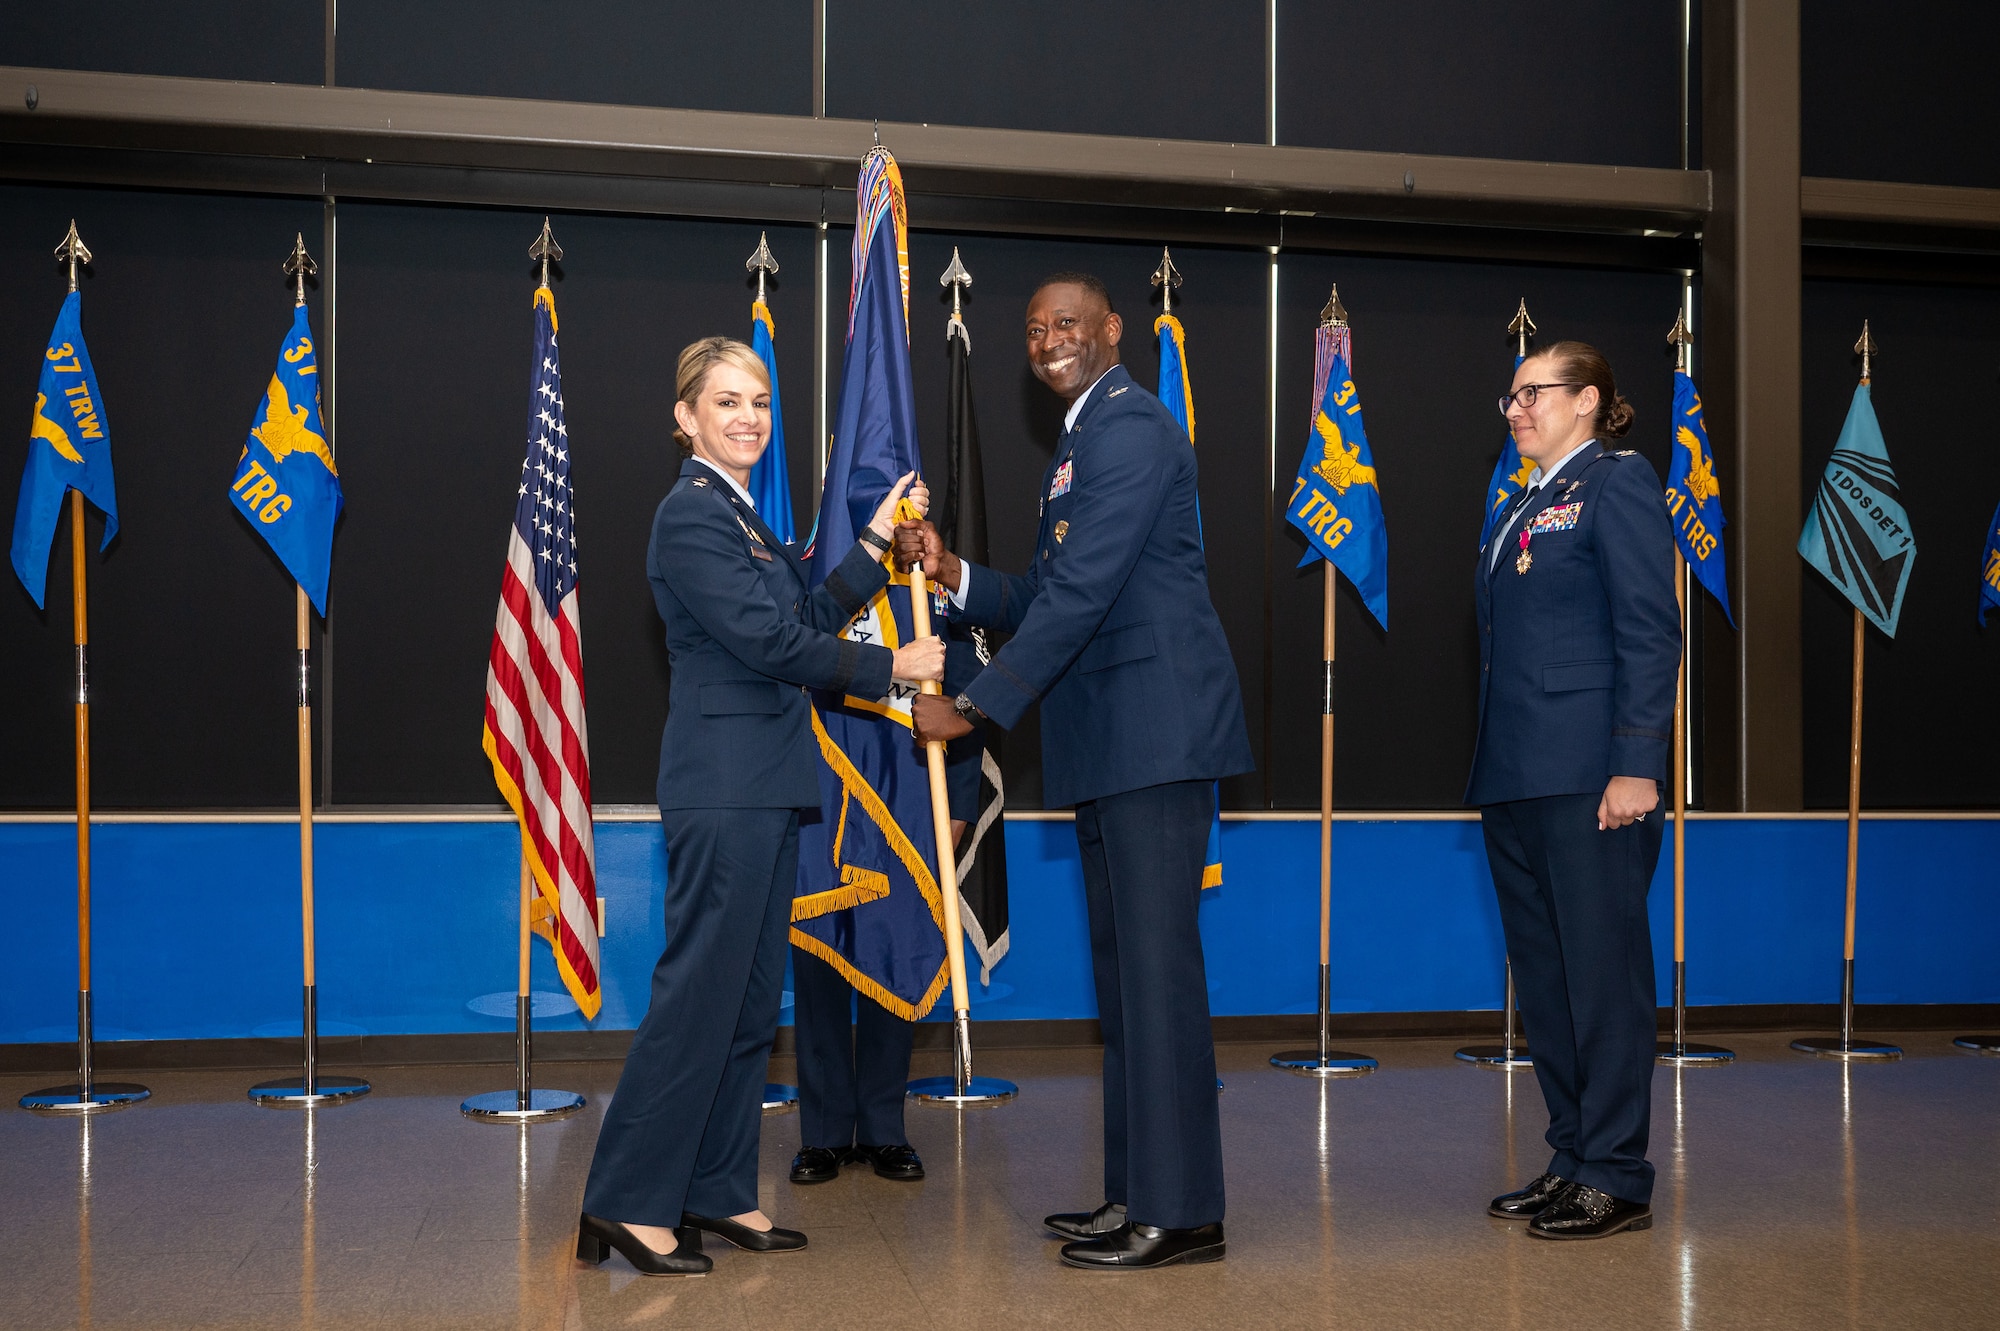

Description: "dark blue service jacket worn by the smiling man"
964 366 1256 807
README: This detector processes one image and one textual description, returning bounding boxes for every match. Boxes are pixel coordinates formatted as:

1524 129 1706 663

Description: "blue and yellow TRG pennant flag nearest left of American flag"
230 306 340 616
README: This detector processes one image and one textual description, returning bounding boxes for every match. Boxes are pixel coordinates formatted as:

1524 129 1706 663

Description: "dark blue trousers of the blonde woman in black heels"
584 809 798 1225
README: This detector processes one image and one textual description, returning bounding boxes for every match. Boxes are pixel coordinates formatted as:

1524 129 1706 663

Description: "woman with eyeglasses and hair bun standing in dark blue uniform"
1466 342 1680 1239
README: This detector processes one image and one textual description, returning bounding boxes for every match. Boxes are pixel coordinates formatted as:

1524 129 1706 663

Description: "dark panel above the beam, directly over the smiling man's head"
826 0 1264 144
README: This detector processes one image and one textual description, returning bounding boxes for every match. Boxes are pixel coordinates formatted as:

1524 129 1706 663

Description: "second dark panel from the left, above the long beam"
334 0 812 116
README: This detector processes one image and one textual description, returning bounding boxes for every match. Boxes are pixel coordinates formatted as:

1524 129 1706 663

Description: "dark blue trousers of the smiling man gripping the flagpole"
1076 781 1222 1229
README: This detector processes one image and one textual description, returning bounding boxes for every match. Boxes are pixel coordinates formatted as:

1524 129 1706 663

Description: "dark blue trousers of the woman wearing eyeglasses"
1480 795 1664 1201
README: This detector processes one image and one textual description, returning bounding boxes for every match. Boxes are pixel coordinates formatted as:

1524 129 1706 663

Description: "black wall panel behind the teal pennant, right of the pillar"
1800 273 2000 809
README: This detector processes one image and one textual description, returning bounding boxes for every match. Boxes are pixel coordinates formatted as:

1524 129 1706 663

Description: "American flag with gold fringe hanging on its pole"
484 286 602 1017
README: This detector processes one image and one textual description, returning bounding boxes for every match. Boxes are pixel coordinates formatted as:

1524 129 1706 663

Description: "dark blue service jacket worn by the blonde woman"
646 458 894 809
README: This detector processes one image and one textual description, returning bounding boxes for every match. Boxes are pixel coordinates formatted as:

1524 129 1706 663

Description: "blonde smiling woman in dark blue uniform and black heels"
576 338 944 1275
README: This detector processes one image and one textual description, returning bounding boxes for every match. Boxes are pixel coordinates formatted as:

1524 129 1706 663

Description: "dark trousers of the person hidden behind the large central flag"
792 947 916 1149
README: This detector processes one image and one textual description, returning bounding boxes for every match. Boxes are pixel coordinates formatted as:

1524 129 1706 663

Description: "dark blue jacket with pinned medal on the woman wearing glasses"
1466 442 1680 805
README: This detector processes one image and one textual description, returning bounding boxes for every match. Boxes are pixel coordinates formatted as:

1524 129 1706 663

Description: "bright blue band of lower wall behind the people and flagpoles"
0 817 2000 1043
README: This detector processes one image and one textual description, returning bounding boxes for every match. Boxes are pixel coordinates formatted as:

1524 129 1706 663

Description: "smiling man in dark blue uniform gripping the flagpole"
898 272 1254 1269
